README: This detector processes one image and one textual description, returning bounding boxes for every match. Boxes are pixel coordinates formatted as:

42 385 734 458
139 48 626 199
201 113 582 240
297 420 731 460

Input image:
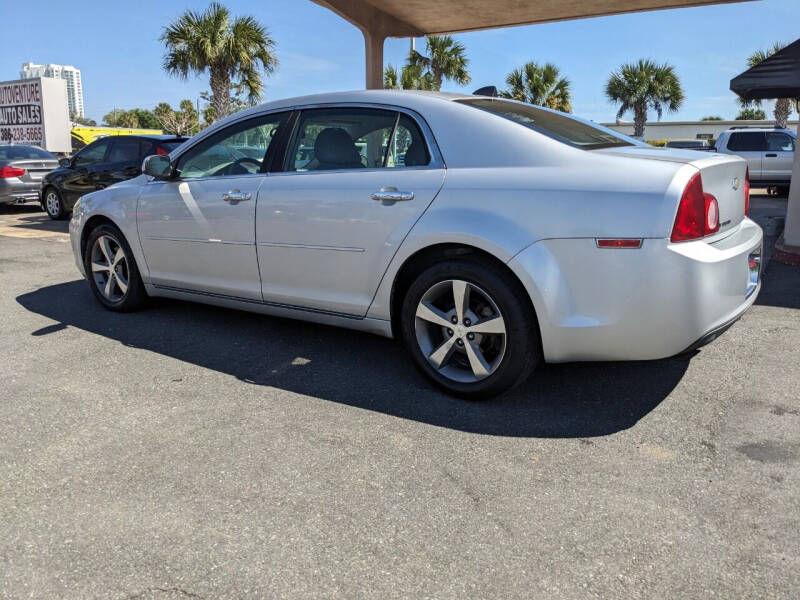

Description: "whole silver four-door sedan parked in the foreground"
70 90 762 398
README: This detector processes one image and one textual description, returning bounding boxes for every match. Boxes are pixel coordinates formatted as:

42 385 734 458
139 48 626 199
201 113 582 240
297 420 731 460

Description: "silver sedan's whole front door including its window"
137 113 288 300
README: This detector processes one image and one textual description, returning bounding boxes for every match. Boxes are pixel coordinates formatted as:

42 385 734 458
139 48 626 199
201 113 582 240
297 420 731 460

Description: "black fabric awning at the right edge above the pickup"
731 40 800 100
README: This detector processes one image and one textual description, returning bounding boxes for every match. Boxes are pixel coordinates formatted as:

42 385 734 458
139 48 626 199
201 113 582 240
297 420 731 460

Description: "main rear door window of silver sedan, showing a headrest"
284 108 397 171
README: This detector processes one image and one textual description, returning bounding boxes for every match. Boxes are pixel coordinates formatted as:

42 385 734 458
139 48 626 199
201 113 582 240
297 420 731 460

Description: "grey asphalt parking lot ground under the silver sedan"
0 197 800 599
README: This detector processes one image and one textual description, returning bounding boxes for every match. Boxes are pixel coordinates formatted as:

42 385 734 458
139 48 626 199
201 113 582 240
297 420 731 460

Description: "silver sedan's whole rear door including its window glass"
256 106 444 316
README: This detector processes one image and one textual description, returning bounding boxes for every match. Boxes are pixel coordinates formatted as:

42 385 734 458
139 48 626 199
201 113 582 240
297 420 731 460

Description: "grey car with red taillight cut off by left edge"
0 146 58 204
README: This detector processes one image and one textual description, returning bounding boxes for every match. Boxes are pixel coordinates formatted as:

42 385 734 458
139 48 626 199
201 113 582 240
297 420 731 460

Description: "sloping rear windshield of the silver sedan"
456 98 634 150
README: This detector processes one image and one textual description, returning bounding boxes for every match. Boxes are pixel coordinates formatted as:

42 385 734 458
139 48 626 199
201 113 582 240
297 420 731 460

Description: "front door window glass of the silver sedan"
177 113 288 179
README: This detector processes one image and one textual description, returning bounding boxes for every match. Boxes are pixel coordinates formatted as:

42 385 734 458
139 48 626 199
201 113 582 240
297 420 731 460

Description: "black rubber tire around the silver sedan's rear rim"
400 259 541 400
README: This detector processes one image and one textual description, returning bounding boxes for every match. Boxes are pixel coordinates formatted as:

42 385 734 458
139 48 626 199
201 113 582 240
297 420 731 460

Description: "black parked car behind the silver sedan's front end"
39 135 187 219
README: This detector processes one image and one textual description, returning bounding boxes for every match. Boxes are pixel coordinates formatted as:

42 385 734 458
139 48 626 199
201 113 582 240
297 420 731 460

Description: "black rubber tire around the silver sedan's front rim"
83 223 147 312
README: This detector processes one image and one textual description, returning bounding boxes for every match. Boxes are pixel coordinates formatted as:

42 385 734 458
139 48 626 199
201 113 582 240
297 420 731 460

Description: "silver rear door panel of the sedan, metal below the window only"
256 169 444 316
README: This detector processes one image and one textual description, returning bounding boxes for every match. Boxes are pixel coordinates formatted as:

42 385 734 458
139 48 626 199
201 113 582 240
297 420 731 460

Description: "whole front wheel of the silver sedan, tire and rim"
83 224 147 312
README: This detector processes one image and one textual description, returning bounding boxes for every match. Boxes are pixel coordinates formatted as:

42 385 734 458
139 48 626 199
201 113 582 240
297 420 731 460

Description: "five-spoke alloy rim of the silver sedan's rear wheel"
414 279 507 383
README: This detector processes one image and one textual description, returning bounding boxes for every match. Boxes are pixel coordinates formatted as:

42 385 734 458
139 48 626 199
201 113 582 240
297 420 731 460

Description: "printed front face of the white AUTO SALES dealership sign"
0 79 44 147
